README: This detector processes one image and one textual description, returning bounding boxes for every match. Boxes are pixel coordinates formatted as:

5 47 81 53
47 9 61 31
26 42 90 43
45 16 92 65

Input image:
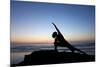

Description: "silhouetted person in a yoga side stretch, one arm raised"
52 23 86 54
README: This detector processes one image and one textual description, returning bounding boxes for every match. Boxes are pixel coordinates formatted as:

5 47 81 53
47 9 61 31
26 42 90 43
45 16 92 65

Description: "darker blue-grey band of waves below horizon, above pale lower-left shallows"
11 43 95 53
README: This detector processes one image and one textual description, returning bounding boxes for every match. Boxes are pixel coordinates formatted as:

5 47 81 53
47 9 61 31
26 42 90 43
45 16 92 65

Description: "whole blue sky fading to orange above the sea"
10 1 95 43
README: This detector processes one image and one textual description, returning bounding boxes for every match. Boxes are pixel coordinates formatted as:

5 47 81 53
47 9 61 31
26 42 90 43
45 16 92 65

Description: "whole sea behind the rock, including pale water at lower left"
10 43 95 64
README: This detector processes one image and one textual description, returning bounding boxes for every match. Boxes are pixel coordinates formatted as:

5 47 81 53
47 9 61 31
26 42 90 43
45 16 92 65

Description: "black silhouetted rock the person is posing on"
11 50 95 67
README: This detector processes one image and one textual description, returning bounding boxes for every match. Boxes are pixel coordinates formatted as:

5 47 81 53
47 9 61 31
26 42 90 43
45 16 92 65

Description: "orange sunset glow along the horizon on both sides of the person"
11 35 95 44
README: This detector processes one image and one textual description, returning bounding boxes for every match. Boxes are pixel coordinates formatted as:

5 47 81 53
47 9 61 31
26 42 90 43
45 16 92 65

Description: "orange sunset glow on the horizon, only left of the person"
11 36 53 43
